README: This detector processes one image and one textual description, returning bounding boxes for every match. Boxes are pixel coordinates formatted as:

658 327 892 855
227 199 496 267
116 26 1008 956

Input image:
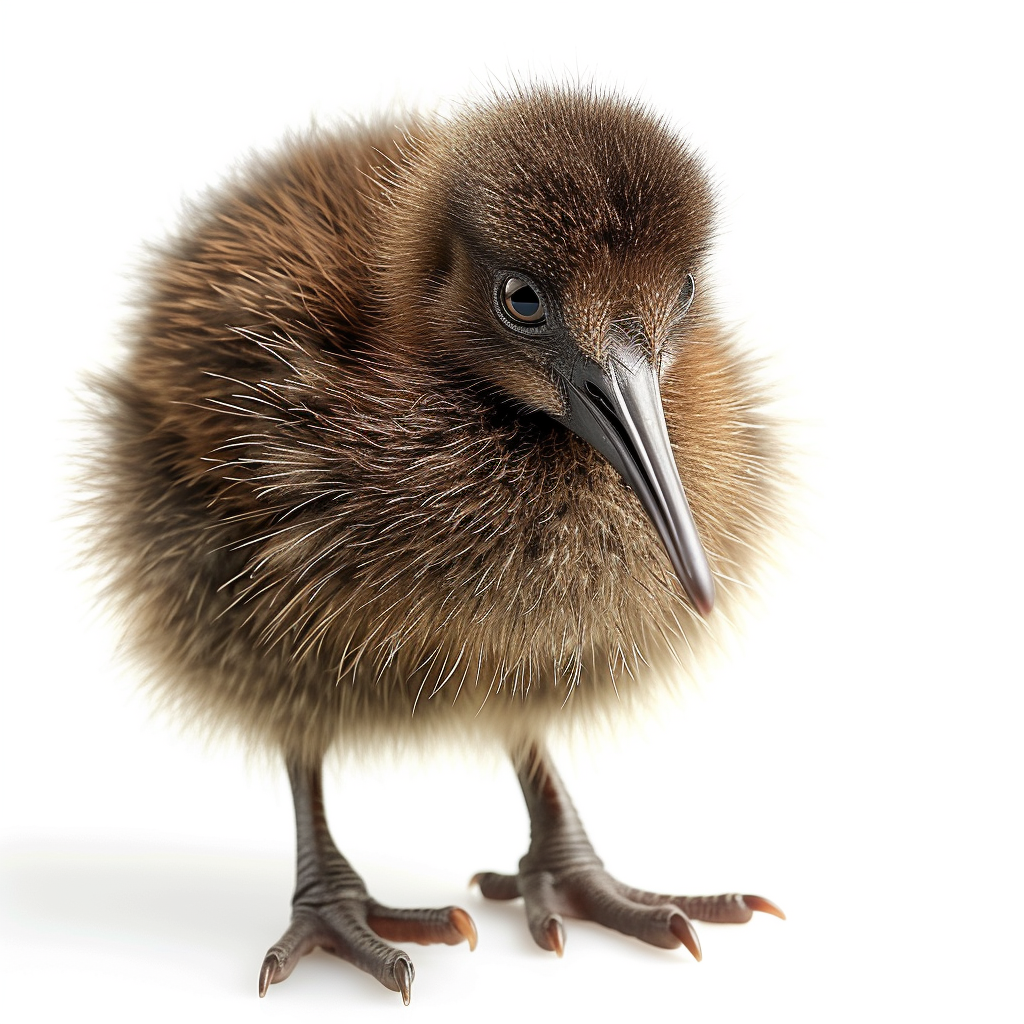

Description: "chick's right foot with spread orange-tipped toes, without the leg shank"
473 854 785 959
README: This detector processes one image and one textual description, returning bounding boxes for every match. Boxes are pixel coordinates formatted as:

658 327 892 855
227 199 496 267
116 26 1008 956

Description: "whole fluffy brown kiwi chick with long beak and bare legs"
89 86 781 1002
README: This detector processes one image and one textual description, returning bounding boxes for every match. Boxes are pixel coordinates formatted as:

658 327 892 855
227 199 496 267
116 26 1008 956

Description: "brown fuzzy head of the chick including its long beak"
383 89 715 615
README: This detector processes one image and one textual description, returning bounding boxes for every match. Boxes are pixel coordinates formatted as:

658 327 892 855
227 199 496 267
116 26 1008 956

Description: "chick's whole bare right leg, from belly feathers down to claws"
473 748 785 959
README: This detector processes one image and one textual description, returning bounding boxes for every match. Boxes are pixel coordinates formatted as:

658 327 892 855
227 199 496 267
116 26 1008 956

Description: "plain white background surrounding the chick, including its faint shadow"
0 0 1024 1022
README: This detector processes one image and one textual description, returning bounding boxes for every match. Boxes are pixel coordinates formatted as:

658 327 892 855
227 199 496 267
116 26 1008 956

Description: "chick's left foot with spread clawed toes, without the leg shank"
259 889 476 1007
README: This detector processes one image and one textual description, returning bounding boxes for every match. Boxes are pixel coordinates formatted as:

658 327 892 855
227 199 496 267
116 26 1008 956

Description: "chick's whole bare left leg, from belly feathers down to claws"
259 763 476 1006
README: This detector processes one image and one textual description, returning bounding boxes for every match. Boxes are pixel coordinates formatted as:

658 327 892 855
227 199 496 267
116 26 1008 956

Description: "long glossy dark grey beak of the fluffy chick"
558 344 715 616
